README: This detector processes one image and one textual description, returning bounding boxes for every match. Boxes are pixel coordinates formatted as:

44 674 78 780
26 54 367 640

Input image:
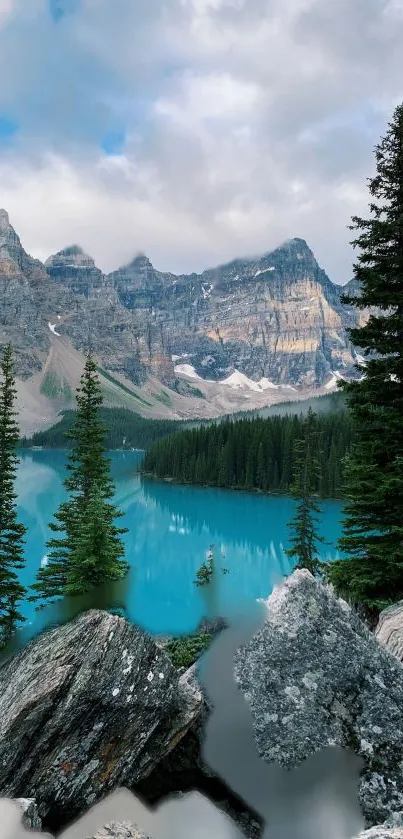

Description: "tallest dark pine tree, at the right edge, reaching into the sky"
328 105 403 617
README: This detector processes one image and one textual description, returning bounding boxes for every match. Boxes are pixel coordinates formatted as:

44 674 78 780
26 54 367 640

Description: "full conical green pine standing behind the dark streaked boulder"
31 353 129 601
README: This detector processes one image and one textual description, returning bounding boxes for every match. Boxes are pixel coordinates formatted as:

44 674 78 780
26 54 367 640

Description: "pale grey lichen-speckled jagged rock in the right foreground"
235 571 403 826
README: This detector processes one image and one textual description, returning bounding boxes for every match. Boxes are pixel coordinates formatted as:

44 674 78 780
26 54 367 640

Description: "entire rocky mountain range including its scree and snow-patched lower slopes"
0 210 367 433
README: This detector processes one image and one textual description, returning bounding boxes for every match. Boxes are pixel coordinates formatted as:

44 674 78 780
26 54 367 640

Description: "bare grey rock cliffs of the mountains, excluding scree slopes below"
0 210 366 391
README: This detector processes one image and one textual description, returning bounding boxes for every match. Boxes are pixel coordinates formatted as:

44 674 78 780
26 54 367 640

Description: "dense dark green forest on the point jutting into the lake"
143 411 352 498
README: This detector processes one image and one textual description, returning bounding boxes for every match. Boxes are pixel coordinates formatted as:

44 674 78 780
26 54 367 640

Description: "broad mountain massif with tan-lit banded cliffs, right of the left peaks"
108 239 360 387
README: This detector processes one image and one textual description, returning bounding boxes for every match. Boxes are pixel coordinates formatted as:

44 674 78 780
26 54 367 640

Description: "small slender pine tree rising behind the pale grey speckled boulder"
287 408 324 574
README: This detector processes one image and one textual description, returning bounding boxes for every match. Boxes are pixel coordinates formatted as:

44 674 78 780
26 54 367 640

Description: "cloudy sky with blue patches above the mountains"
0 0 403 283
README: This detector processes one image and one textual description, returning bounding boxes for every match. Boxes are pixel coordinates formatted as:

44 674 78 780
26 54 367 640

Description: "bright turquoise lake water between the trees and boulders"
17 451 342 634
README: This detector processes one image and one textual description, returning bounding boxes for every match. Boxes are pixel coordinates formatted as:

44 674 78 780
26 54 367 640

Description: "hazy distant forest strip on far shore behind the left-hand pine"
20 408 183 449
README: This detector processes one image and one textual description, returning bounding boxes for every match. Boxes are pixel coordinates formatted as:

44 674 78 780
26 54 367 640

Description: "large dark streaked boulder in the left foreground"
0 611 203 831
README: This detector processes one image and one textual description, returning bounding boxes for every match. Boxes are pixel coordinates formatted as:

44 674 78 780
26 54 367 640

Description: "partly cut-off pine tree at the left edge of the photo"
0 346 26 646
